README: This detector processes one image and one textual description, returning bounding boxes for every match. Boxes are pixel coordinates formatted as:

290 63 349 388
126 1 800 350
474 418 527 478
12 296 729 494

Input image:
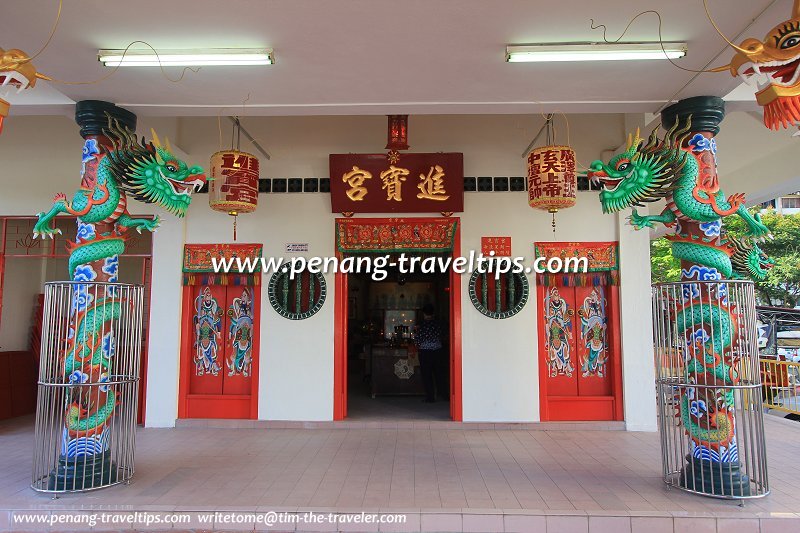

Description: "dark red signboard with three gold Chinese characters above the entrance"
330 153 464 213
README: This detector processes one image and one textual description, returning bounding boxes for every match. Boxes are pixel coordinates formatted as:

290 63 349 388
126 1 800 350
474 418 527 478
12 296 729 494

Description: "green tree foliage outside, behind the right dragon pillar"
650 210 800 307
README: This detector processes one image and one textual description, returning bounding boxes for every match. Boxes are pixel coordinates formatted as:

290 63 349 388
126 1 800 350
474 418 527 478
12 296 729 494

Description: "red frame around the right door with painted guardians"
536 278 624 422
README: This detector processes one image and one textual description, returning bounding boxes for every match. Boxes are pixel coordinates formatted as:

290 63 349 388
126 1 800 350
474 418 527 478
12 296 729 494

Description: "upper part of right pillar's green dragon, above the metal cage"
588 121 772 281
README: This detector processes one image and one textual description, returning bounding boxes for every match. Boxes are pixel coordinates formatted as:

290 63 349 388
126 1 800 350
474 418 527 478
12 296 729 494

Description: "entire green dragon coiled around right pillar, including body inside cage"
587 117 773 484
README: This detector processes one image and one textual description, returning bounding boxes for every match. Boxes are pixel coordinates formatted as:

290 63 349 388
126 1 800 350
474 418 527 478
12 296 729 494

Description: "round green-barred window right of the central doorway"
469 271 529 319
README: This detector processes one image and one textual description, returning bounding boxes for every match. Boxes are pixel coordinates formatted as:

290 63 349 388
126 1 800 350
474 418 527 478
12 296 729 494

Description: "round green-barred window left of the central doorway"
267 262 327 320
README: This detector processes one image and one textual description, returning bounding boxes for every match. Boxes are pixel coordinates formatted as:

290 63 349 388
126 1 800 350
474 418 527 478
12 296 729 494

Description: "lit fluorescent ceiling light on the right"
506 42 686 63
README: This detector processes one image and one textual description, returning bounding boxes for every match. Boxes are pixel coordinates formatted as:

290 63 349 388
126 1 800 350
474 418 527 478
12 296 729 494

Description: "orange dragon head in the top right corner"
723 0 800 130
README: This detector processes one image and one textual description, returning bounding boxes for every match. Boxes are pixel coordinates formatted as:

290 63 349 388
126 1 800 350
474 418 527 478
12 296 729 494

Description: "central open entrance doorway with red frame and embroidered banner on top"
333 217 462 421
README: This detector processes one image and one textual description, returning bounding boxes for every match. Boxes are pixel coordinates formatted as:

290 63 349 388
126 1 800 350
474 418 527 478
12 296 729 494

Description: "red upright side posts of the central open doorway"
333 217 463 422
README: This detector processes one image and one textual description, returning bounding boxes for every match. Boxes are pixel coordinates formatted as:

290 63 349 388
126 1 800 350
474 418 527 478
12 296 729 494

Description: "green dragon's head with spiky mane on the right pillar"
587 121 691 213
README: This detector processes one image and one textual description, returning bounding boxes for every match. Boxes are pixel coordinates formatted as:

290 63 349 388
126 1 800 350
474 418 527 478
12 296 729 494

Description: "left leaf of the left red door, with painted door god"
189 285 226 394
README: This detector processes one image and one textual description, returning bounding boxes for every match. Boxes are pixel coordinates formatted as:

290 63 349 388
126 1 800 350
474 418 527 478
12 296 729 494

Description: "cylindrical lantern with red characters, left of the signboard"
208 150 258 240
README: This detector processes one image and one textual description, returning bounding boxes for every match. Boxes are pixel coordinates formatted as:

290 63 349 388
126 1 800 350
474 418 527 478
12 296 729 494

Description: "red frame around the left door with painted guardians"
178 280 261 420
